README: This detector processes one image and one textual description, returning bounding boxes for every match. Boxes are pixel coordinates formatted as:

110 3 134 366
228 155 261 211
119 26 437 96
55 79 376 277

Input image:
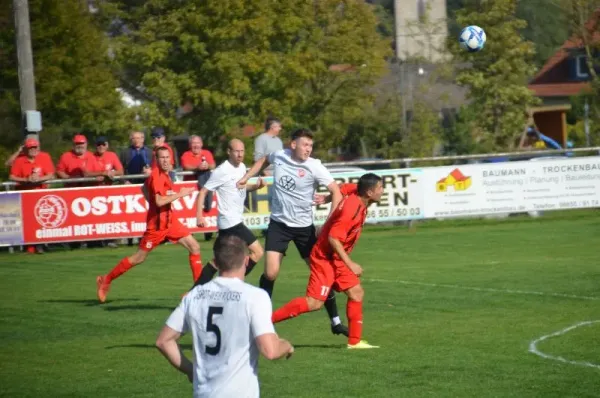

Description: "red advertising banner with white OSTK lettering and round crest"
20 181 217 244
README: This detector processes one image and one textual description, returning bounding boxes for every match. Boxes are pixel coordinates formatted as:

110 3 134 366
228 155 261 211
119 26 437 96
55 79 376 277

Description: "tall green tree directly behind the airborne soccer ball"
450 0 537 151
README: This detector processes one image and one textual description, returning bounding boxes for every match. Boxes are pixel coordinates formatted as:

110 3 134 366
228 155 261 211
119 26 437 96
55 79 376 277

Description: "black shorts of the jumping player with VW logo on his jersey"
265 219 317 258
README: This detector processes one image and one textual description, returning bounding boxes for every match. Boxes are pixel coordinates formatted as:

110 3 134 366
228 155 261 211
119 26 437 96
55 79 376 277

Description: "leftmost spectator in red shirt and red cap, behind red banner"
10 138 55 254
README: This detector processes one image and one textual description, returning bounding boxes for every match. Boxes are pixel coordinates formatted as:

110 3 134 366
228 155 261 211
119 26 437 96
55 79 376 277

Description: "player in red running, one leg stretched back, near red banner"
96 148 202 303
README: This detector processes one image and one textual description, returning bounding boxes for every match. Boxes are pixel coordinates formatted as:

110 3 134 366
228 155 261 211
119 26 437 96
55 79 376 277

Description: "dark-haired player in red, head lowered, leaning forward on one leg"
272 173 383 349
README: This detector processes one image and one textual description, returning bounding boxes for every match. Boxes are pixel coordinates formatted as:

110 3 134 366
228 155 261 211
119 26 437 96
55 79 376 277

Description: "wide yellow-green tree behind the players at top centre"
102 0 389 146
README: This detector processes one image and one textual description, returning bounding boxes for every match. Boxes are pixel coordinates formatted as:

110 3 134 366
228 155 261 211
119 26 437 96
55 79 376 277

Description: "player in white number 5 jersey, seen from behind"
156 235 294 398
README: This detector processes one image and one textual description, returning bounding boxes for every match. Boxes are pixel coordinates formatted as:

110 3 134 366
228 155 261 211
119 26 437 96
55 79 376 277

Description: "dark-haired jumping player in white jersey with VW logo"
238 129 348 336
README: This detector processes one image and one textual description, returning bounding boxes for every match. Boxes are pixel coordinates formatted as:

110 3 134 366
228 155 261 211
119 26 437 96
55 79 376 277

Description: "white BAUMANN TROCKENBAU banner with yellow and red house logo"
423 156 600 218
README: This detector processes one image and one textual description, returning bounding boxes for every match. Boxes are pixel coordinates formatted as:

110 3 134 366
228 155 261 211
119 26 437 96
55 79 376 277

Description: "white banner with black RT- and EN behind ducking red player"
314 169 424 225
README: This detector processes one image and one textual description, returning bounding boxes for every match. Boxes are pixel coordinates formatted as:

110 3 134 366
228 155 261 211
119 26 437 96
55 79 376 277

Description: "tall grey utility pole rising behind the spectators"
13 0 36 135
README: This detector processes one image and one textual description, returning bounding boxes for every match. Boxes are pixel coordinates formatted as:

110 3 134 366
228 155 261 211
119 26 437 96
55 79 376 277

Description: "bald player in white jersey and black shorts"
194 139 264 286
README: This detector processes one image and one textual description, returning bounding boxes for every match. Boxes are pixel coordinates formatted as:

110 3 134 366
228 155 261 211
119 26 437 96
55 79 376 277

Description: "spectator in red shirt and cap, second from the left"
56 134 96 187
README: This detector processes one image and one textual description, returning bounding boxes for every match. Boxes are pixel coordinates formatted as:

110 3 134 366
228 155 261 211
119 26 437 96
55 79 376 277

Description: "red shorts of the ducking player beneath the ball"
306 256 360 301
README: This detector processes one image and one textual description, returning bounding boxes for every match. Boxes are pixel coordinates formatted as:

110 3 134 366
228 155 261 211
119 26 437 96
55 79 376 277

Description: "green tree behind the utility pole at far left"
0 0 133 169
